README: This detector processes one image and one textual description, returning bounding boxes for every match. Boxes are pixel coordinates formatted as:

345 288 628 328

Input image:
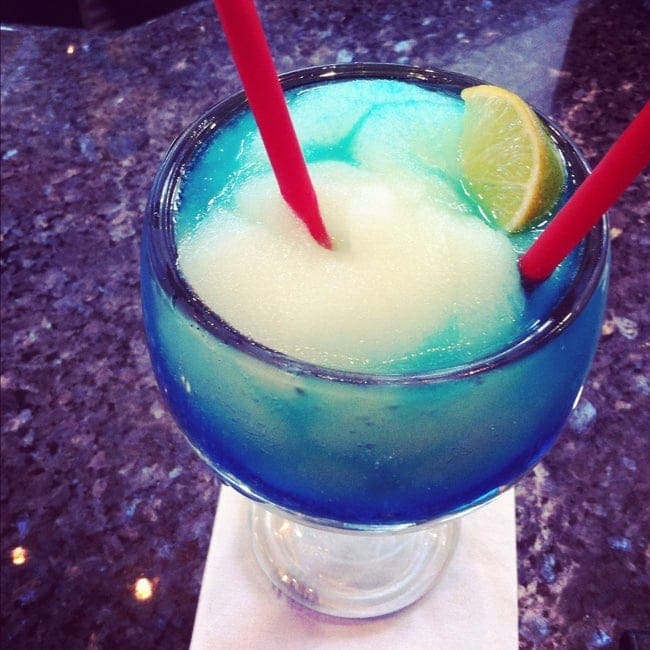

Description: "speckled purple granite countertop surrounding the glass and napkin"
0 0 650 649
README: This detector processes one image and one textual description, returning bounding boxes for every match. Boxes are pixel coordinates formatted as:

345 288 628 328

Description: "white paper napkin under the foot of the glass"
190 487 518 650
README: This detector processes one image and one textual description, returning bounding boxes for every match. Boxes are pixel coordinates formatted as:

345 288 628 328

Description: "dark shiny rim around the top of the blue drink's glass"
142 63 609 385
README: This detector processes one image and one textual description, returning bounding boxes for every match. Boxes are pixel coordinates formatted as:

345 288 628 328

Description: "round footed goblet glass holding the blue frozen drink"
141 64 609 617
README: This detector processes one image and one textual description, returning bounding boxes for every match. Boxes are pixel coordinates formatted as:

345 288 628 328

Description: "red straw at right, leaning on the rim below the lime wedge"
519 102 650 283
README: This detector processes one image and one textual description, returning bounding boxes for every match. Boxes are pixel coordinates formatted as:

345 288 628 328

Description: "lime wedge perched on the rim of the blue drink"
460 86 565 232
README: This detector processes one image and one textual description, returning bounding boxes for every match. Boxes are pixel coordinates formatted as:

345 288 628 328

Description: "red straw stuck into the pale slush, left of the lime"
214 0 332 248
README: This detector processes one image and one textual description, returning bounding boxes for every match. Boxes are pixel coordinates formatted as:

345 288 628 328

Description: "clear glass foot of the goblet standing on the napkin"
250 503 460 618
